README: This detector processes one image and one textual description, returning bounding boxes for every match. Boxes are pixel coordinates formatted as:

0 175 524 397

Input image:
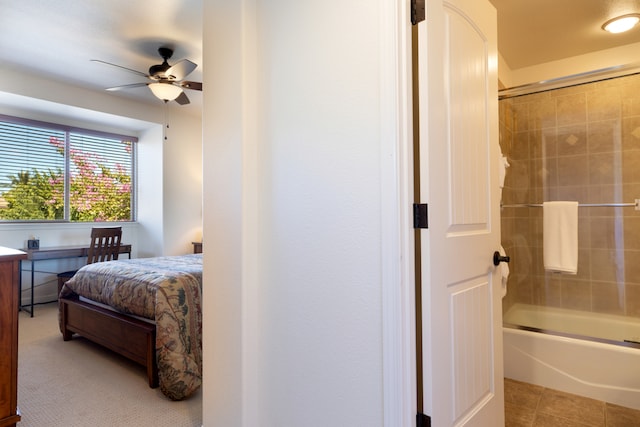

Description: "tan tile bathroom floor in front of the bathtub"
504 378 640 427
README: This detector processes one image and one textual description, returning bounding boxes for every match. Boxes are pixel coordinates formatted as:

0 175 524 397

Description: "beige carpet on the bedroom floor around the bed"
18 303 202 427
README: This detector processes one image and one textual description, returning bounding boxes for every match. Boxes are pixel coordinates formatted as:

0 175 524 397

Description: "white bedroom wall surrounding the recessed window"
0 66 202 301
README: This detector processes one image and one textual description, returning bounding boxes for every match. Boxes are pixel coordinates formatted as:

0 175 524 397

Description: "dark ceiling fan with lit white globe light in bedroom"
92 46 202 105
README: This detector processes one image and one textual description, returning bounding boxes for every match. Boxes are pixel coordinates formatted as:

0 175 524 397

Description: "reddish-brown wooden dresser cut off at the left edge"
0 246 27 427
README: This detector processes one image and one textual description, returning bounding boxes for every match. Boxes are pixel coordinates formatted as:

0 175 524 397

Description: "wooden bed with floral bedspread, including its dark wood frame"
59 254 202 400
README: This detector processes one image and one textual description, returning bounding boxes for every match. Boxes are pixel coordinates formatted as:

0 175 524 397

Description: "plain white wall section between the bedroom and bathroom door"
203 0 408 427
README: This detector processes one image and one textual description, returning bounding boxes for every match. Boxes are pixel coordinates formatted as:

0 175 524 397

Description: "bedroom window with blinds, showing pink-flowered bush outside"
0 115 137 222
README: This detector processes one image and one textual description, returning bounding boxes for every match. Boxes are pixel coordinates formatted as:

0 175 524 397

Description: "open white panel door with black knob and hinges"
418 0 504 427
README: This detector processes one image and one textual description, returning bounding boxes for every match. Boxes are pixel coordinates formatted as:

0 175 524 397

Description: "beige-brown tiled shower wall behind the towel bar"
499 75 640 317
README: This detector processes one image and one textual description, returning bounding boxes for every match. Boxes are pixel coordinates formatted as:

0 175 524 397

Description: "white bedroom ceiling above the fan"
0 0 203 112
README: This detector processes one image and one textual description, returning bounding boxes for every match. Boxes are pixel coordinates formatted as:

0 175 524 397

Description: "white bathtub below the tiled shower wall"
503 304 640 409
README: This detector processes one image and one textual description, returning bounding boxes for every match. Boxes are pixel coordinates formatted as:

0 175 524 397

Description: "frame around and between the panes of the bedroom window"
0 114 138 224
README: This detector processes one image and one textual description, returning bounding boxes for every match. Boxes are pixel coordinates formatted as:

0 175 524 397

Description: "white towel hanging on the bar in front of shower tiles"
542 202 578 274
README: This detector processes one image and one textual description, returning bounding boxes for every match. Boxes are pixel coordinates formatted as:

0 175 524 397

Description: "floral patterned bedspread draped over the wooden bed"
62 254 202 400
